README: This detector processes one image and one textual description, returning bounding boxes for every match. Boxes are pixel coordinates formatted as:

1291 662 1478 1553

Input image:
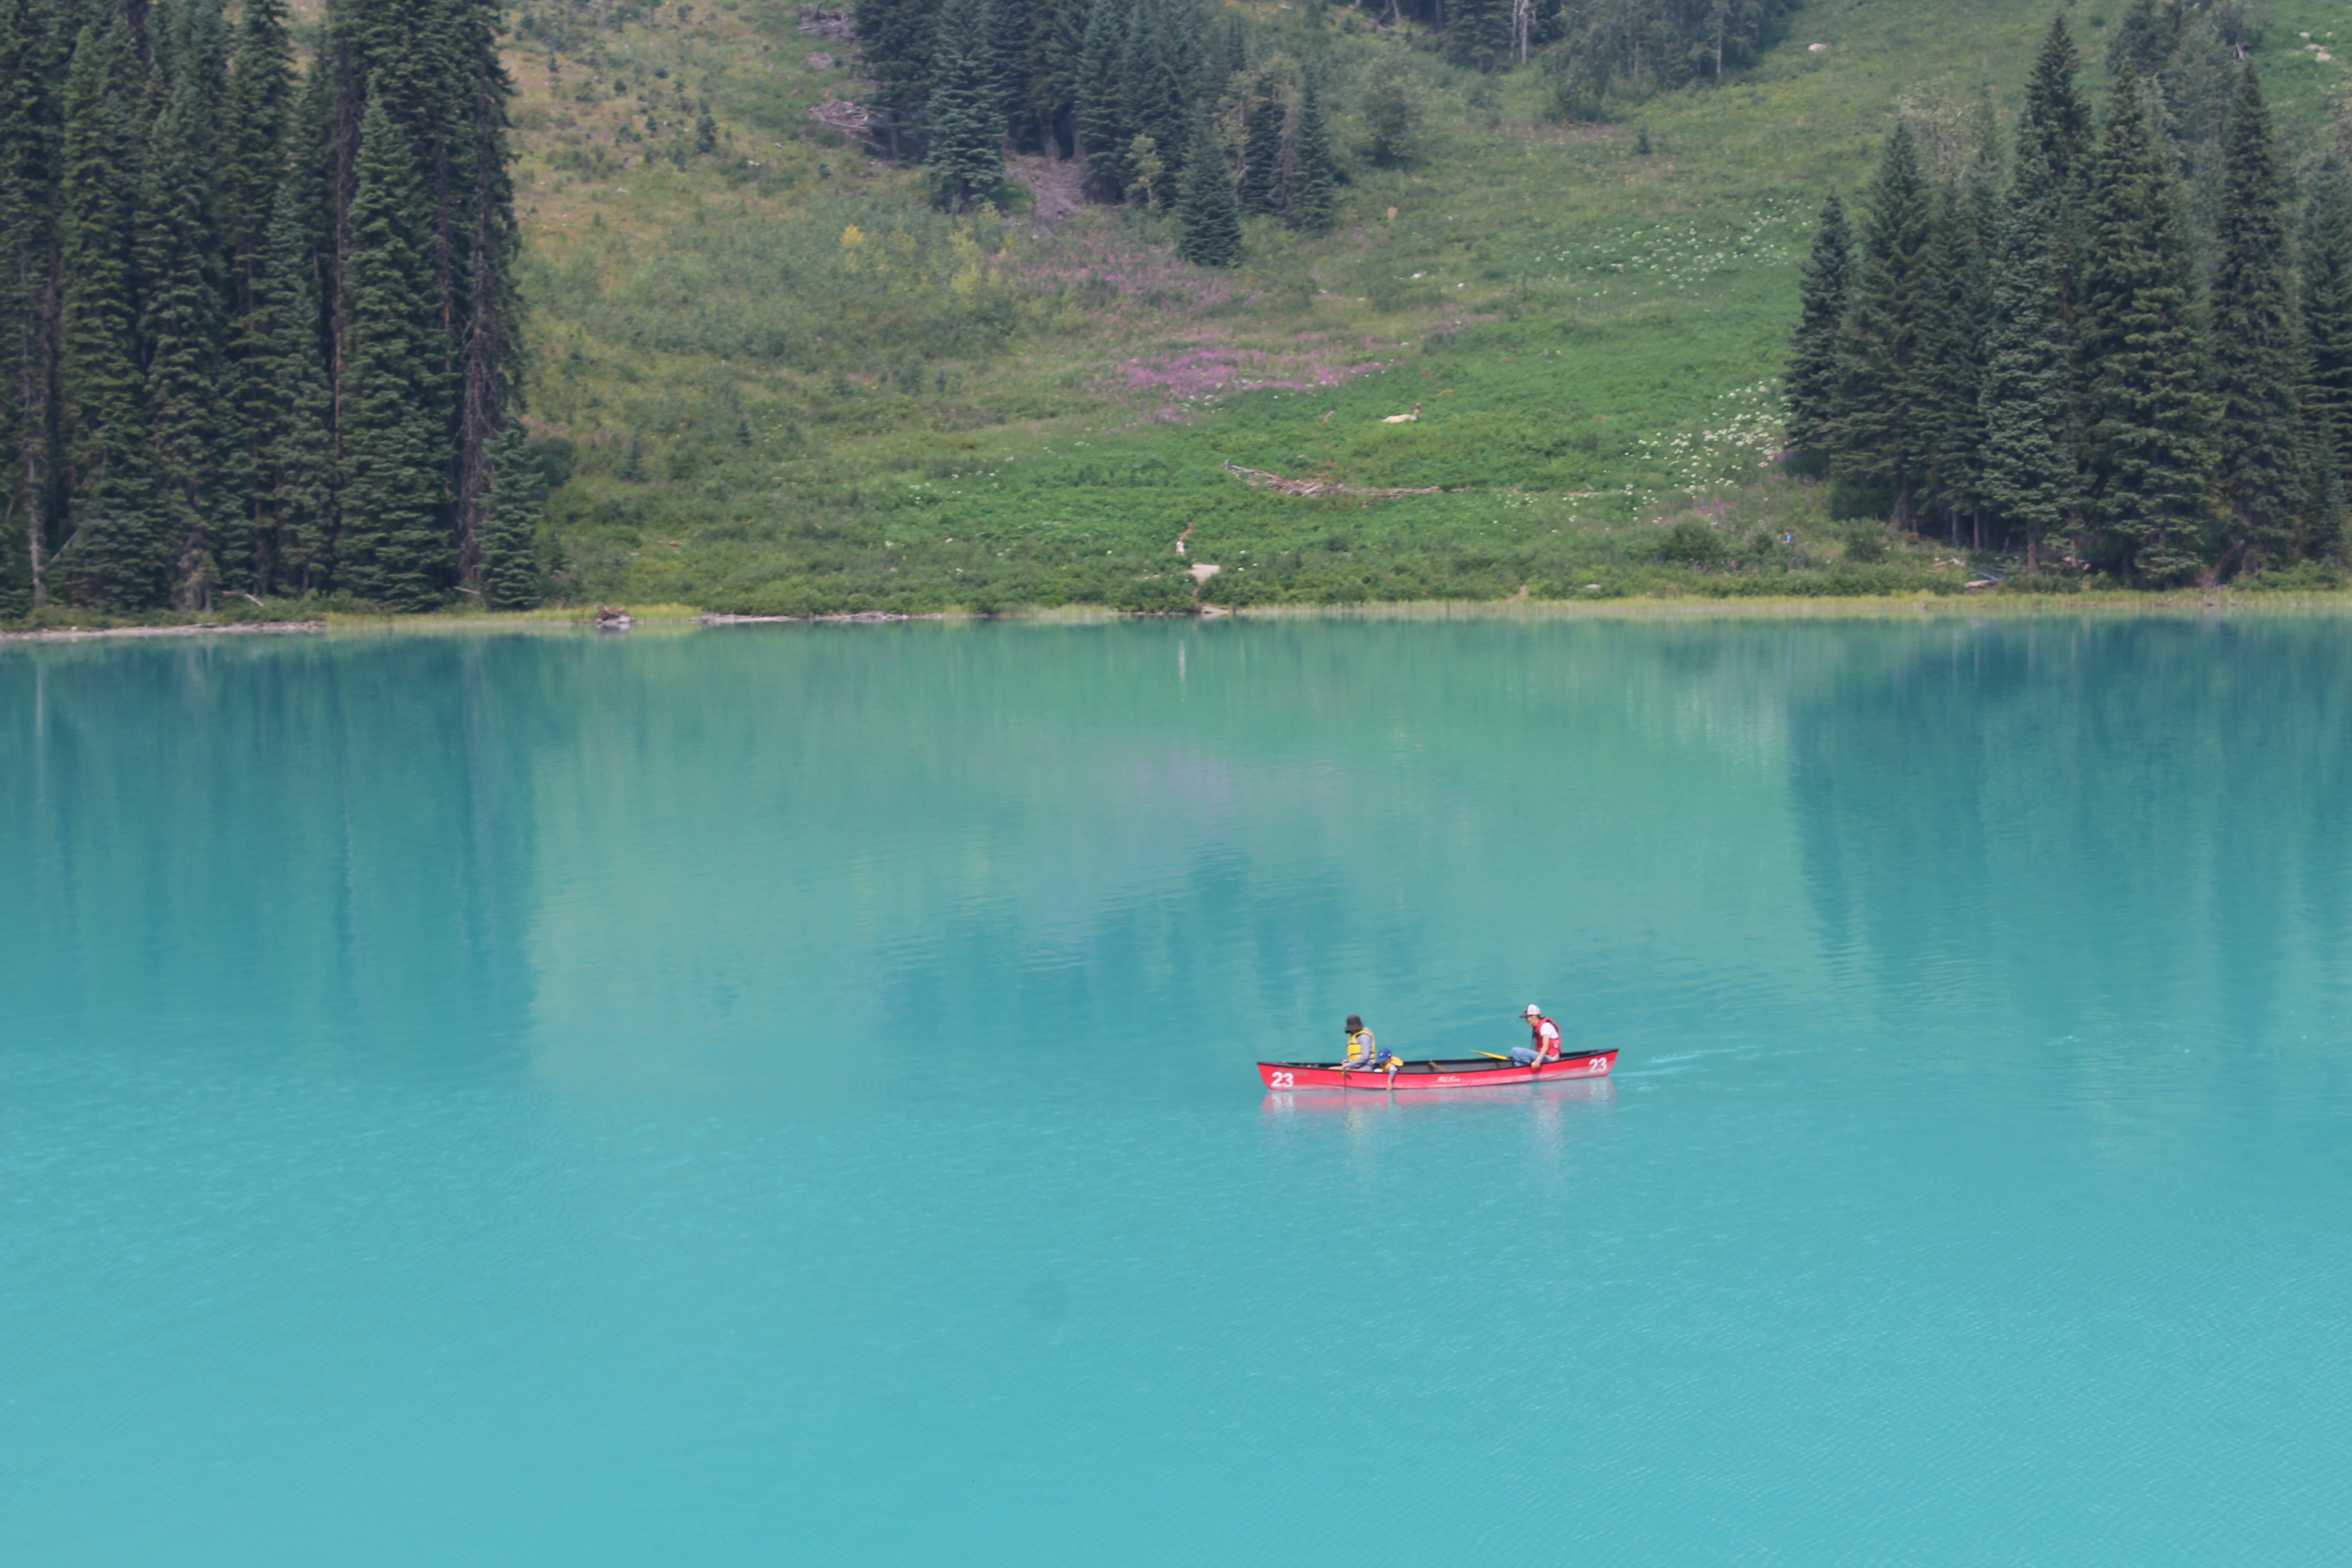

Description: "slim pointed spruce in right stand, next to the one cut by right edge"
2211 66 2307 571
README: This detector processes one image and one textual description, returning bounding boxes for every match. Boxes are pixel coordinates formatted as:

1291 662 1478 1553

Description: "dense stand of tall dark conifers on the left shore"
0 0 538 614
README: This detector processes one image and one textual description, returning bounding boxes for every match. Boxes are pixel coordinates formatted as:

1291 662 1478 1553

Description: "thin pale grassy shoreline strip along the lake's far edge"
14 588 2352 644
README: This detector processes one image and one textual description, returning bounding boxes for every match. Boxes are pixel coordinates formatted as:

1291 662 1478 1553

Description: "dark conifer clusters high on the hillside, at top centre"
856 0 1795 240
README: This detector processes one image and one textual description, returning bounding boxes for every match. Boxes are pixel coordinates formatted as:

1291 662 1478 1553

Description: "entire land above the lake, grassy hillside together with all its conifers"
0 0 2352 632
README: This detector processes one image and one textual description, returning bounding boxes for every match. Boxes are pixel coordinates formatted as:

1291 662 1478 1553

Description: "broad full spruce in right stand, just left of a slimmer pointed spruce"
2082 63 2213 585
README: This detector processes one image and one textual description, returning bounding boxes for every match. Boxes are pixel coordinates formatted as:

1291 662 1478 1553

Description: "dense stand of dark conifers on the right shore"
1788 0 2352 588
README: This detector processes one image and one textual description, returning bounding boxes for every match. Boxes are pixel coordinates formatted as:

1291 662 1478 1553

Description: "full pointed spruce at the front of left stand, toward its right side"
336 99 454 609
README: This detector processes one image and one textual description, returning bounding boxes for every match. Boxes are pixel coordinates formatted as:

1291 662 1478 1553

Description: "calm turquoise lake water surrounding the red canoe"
0 618 2352 1568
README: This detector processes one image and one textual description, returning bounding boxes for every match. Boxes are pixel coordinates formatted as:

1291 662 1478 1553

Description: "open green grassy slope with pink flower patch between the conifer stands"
510 0 2352 614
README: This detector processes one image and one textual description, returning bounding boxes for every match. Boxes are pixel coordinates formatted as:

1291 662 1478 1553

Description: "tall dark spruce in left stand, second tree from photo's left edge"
56 16 162 609
